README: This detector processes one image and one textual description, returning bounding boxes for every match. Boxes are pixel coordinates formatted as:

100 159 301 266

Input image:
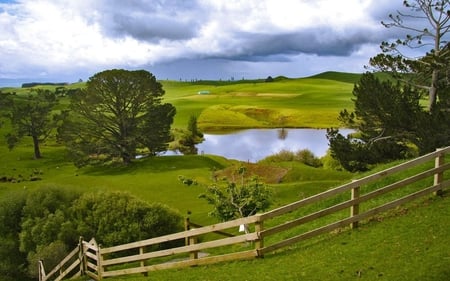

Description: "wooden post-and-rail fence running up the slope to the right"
39 147 450 281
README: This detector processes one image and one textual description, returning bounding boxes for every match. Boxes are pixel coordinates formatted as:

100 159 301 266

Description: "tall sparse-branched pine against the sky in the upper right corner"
370 0 450 112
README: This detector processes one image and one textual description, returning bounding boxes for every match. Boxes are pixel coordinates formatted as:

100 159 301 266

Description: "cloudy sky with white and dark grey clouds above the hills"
0 0 422 82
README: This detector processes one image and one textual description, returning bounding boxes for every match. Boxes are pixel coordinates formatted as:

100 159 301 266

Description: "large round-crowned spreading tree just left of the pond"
61 69 175 165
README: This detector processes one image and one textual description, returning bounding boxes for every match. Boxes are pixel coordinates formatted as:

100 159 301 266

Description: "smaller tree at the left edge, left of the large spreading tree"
0 89 58 159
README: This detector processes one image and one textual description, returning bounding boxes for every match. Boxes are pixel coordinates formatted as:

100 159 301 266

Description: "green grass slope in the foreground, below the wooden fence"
74 193 450 281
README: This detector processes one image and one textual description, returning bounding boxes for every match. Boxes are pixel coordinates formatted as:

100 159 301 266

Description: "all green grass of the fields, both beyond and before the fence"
0 72 450 281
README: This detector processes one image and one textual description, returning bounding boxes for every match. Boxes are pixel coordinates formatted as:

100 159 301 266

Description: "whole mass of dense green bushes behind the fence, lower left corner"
0 187 183 281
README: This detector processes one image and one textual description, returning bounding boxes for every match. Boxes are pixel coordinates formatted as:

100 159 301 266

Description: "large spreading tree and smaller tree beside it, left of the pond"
0 69 176 166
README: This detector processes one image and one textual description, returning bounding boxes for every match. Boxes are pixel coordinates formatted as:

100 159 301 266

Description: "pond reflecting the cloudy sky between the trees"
197 129 352 162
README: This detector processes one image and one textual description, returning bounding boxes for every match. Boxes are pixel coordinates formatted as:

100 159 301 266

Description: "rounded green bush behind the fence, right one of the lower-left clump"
71 189 183 247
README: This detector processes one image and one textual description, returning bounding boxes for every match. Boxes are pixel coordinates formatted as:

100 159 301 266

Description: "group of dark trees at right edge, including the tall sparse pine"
327 0 450 171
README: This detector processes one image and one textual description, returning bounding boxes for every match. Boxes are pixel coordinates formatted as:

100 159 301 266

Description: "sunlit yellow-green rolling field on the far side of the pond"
162 72 353 131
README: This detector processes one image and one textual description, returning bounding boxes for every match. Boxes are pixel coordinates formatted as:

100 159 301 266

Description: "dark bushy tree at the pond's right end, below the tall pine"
327 73 429 172
